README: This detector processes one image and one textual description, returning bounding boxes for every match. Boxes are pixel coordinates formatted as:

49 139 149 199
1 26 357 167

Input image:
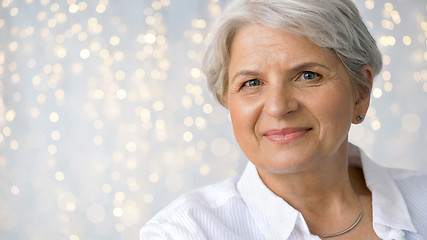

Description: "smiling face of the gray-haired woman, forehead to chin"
226 25 369 173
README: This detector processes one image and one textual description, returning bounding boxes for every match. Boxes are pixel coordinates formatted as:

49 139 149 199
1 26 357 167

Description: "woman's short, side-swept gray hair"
202 0 382 106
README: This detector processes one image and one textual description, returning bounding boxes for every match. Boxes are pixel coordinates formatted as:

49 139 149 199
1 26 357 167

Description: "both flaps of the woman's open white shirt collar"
237 146 417 239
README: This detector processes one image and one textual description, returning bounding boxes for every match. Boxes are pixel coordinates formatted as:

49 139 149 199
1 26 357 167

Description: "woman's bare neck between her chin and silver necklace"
258 144 360 232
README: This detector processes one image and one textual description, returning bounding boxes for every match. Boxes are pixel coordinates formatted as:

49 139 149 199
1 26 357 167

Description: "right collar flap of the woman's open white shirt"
360 151 416 233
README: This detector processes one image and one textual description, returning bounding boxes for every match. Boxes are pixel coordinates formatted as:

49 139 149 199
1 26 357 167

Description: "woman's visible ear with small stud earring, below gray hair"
353 65 374 124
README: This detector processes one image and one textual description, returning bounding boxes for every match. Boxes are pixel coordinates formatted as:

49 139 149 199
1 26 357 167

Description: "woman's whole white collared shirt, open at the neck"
140 149 427 240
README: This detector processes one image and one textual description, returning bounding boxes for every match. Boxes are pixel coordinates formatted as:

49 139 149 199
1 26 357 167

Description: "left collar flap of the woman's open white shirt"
237 162 309 239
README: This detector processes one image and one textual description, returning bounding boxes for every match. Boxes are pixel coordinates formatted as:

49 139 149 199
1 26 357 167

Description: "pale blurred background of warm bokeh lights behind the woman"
0 0 427 240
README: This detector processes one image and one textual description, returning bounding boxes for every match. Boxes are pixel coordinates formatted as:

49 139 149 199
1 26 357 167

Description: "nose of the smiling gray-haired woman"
264 84 300 118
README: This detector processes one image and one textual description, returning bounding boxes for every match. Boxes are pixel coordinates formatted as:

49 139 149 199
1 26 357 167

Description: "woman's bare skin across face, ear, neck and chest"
224 25 376 239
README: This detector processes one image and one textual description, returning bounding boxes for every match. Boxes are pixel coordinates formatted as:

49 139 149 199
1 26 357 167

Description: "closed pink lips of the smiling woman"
264 128 311 144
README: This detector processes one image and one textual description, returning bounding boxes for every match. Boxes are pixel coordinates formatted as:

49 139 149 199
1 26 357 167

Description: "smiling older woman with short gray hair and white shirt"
140 0 427 240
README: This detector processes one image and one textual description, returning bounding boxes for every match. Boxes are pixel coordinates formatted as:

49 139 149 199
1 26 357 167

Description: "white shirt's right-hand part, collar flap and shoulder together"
362 155 427 239
